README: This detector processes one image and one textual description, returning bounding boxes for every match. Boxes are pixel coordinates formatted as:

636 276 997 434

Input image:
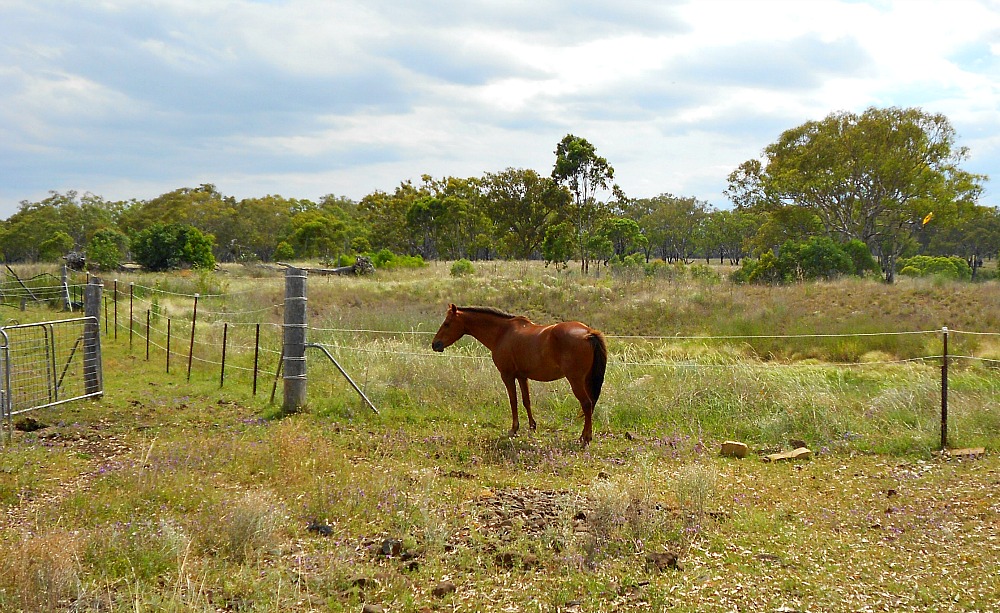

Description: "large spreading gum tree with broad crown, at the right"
727 107 985 283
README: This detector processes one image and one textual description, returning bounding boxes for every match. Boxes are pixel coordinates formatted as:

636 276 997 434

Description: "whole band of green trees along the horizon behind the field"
0 108 1000 282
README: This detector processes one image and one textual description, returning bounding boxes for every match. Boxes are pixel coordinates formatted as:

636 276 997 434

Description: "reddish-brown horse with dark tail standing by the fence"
431 304 608 447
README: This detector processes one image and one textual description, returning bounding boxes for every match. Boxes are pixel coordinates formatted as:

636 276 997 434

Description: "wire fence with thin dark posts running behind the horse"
15 268 1000 450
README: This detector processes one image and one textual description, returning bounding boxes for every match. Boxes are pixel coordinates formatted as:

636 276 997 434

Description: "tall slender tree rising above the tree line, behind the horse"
552 134 619 272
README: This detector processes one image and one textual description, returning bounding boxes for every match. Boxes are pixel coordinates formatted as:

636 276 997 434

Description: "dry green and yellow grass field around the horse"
0 263 1000 611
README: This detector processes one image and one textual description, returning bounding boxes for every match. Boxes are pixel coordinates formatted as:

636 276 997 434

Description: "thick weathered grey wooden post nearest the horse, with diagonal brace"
281 267 307 413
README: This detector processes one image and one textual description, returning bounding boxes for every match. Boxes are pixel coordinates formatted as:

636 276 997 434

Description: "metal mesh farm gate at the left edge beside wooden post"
0 317 104 420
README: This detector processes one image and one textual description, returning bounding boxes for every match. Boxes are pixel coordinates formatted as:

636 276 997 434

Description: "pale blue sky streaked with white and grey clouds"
0 0 1000 218
